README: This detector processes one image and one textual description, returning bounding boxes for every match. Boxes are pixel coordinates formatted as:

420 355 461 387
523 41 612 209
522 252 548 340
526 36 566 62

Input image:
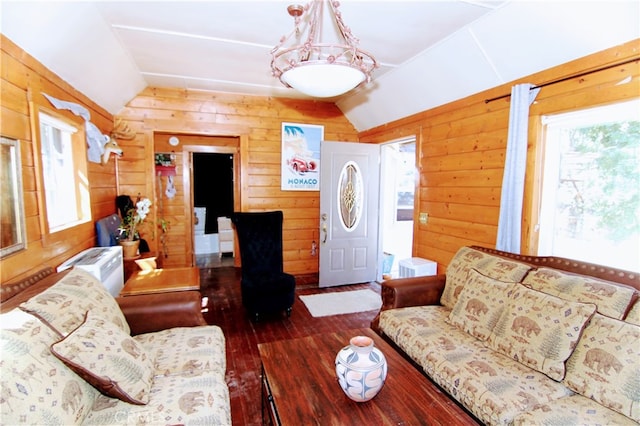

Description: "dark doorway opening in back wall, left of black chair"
192 152 234 268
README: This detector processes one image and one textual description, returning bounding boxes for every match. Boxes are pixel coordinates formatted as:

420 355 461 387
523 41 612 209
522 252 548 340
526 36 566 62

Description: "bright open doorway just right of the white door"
378 137 416 280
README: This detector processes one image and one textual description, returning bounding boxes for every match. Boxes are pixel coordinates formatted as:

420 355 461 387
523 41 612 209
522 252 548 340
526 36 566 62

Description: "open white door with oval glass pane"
319 141 380 287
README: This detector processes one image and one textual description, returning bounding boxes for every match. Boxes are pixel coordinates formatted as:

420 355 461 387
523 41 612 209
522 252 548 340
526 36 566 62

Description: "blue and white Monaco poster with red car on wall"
281 123 324 191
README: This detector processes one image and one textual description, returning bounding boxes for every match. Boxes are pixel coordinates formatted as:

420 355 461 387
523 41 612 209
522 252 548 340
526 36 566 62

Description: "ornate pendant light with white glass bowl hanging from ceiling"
271 0 378 98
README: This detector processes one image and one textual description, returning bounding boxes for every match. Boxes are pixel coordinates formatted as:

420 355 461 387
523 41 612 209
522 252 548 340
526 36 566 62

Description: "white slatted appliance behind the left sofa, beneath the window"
57 246 124 297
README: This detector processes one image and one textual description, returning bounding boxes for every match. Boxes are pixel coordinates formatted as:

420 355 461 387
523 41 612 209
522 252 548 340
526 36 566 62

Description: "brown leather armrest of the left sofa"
116 291 207 335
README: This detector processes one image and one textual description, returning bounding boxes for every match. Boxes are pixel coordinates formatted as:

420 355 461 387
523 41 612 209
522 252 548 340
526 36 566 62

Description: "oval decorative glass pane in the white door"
336 161 364 231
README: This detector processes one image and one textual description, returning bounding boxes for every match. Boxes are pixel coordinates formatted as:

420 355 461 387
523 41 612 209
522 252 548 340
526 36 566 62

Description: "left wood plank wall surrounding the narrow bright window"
0 34 116 283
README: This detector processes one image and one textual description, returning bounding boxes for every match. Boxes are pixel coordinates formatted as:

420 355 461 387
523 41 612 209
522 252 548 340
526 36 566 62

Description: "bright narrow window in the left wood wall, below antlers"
39 112 91 233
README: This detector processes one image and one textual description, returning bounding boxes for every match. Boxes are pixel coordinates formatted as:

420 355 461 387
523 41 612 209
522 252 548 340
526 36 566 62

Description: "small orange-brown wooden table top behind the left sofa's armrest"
120 267 200 296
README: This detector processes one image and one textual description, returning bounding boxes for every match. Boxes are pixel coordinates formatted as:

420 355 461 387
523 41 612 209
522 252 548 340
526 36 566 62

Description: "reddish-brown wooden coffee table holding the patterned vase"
258 328 479 425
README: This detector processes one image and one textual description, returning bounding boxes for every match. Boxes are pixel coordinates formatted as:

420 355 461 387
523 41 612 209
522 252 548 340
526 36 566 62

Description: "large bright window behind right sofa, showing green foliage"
538 100 640 271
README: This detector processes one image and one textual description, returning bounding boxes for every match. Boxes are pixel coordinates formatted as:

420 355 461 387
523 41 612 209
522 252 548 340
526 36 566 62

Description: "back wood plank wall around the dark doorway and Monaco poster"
112 88 358 275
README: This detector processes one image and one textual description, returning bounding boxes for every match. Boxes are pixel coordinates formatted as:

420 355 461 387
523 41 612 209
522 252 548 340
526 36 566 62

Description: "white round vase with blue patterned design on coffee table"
336 336 387 402
